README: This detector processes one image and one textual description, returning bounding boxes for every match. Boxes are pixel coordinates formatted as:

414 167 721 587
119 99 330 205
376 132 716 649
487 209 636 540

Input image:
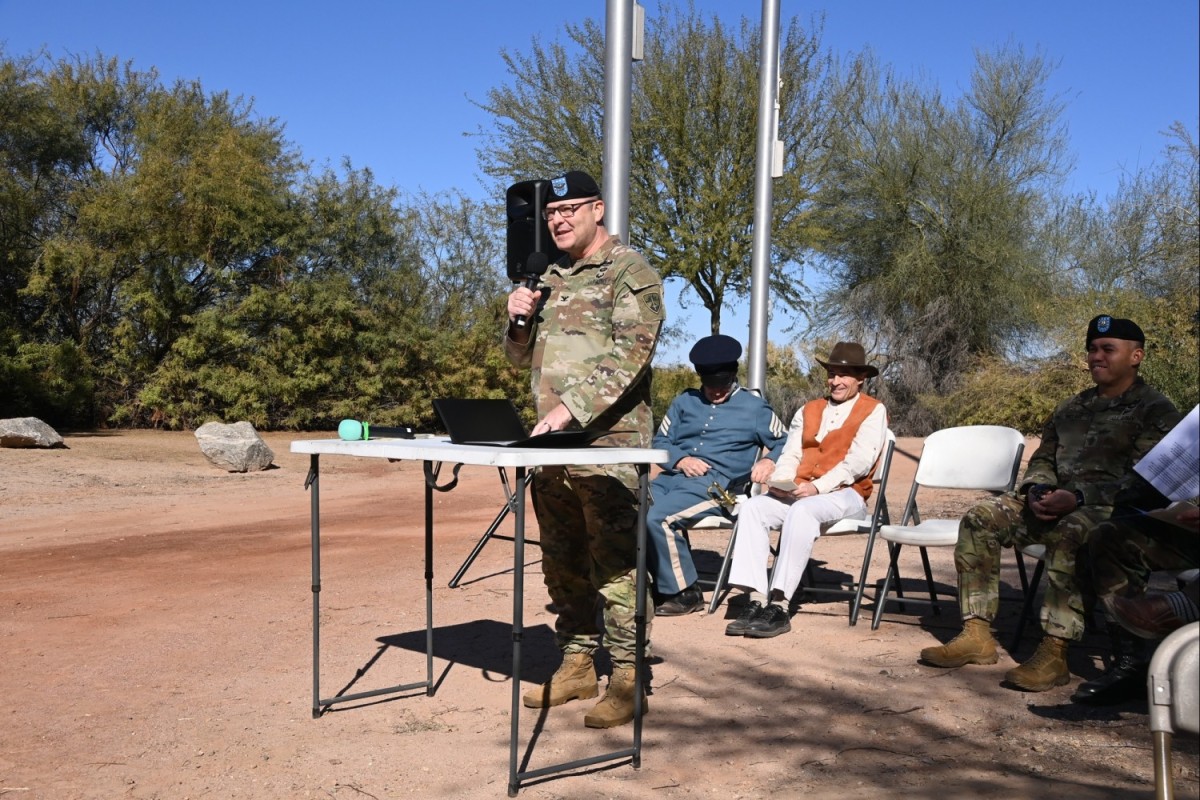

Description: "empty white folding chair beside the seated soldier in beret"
871 425 1025 630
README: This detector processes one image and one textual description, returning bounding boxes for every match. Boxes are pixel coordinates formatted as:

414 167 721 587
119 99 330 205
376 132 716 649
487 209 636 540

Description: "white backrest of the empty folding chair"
914 425 1025 492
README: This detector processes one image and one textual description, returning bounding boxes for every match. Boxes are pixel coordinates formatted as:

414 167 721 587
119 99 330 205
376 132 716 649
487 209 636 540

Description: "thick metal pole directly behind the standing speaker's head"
601 0 634 243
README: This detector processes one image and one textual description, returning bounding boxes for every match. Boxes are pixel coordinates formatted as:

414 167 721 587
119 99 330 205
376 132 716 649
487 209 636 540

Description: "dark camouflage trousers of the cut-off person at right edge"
1085 509 1200 600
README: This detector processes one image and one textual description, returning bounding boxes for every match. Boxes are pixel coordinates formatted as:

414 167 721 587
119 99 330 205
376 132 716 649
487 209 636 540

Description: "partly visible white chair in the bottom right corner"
1146 622 1200 800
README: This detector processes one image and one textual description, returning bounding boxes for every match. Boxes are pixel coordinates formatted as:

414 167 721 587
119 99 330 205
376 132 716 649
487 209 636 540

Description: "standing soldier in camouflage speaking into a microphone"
504 172 665 728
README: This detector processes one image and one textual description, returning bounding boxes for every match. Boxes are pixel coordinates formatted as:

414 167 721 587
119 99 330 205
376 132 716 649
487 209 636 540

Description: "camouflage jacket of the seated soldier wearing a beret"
1020 378 1180 506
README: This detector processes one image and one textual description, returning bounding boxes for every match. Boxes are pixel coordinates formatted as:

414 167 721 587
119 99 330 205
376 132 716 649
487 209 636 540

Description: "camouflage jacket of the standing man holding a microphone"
504 236 666 447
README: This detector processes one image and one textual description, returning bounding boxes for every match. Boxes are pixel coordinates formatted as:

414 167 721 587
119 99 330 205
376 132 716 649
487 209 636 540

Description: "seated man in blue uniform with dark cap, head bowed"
646 335 787 616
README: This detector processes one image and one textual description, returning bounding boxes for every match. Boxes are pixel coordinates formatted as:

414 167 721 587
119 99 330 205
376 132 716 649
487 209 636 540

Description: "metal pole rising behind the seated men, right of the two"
746 0 779 391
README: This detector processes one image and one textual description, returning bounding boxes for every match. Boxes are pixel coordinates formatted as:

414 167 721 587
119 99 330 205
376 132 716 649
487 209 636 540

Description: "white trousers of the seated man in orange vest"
730 488 866 600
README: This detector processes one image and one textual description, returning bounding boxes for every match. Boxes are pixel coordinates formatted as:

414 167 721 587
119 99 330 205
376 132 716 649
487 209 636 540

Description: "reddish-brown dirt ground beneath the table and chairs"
0 432 1200 800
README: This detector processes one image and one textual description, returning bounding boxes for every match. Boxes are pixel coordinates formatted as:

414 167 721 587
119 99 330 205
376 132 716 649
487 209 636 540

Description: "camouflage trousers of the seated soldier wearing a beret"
954 492 1110 642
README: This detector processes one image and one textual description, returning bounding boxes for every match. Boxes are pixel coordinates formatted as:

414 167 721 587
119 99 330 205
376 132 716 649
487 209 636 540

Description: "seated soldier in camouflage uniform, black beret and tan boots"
920 315 1180 692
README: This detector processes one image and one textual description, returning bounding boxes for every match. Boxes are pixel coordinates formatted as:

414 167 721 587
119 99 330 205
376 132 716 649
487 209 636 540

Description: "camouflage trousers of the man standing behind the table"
533 465 654 667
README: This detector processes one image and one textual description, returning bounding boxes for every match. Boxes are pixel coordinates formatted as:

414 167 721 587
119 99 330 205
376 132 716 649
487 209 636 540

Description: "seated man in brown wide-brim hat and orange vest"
725 342 888 639
